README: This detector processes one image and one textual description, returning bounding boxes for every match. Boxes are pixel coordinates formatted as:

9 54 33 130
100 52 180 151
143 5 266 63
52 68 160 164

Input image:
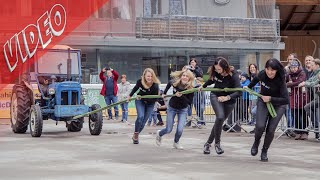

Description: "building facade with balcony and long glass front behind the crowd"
63 0 284 84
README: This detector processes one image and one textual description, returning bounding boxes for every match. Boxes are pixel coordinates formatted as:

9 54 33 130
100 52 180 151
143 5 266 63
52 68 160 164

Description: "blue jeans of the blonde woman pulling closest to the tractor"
134 100 154 133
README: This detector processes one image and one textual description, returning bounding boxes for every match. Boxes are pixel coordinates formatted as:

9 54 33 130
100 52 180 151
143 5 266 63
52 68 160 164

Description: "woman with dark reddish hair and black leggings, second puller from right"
199 57 241 154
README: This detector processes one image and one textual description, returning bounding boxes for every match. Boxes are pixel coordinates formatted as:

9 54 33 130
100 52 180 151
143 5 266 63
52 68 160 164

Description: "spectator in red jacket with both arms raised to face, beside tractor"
99 68 119 120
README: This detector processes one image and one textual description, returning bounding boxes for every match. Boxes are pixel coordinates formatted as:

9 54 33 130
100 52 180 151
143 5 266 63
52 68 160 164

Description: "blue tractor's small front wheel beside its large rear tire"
30 105 43 137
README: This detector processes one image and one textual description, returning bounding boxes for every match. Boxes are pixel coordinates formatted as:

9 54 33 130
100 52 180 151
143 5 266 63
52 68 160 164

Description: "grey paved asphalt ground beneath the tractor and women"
0 117 320 180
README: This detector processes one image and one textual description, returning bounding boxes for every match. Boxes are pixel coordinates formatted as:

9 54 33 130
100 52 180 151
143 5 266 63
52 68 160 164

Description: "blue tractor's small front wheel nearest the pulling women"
89 104 103 136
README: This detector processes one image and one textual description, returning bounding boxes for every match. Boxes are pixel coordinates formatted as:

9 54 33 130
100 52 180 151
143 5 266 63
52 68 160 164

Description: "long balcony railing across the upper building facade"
136 16 281 42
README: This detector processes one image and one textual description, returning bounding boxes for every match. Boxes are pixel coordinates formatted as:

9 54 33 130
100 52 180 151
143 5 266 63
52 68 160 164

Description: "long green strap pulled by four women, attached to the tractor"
73 88 277 119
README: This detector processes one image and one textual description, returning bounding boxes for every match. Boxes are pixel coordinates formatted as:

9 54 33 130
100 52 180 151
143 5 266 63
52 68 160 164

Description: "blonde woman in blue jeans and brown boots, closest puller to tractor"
128 68 160 144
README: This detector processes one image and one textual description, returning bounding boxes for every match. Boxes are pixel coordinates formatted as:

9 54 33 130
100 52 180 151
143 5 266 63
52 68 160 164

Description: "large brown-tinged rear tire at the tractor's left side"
10 84 32 133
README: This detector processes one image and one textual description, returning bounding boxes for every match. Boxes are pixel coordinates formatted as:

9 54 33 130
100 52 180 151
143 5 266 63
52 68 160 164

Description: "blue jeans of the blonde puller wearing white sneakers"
159 106 188 143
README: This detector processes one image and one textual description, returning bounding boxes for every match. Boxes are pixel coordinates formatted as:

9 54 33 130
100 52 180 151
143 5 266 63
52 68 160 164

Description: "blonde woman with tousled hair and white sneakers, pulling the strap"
156 70 194 149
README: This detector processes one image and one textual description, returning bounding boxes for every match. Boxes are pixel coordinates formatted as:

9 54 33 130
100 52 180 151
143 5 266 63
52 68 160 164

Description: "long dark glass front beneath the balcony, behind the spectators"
75 47 270 84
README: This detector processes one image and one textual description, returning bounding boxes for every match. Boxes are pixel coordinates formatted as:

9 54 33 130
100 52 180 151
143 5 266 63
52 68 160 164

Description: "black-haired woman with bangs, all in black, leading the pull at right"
248 58 289 162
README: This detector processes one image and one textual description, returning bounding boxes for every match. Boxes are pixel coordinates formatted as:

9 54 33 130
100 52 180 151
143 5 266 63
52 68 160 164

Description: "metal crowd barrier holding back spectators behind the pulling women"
193 87 320 138
